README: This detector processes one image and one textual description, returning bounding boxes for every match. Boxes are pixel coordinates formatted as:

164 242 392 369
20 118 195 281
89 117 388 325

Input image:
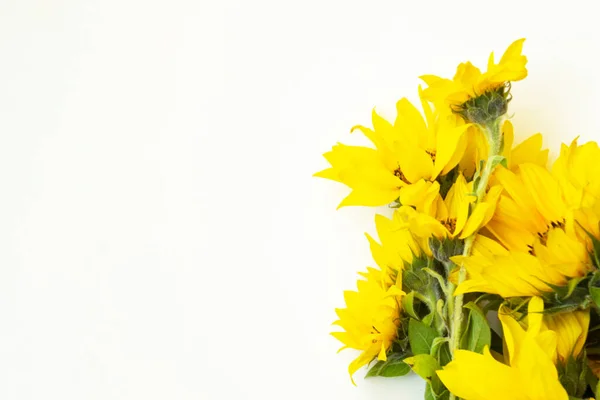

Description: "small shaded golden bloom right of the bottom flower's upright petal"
543 309 590 364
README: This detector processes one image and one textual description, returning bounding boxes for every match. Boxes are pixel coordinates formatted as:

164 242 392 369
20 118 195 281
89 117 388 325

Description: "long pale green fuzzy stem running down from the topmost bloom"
447 118 503 400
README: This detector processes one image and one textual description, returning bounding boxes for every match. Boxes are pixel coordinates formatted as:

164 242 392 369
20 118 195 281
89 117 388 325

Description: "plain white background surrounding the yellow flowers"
0 0 600 400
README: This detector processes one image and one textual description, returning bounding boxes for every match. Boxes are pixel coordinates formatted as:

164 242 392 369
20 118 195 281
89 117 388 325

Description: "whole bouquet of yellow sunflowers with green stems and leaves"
316 39 600 400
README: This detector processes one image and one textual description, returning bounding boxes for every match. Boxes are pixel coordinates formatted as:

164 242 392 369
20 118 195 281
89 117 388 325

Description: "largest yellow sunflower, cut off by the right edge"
454 142 600 297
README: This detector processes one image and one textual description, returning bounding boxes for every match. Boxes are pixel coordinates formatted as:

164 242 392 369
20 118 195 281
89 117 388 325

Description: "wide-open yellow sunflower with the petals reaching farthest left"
315 98 468 210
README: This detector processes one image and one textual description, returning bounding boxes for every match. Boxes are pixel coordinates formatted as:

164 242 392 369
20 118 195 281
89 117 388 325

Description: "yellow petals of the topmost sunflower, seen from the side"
421 39 527 107
